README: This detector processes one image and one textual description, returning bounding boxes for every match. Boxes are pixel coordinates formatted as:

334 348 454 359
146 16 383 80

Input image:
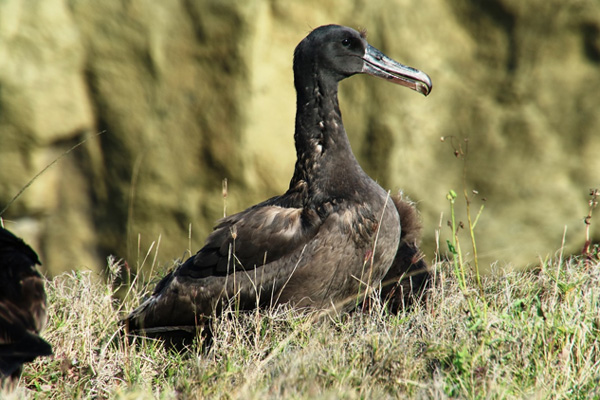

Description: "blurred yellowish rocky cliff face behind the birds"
0 0 600 273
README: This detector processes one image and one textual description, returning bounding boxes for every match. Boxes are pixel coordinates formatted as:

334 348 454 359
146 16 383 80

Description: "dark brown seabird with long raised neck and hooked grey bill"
124 25 431 339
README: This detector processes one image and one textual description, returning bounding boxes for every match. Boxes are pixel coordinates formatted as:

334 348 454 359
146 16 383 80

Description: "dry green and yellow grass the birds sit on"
0 245 600 399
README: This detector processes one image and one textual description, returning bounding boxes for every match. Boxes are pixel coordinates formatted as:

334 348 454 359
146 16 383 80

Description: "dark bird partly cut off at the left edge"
0 227 52 388
